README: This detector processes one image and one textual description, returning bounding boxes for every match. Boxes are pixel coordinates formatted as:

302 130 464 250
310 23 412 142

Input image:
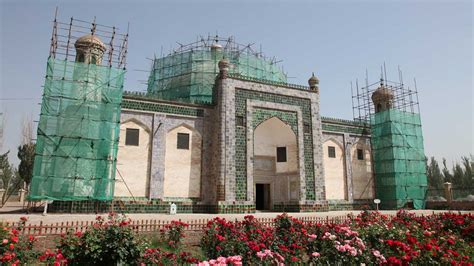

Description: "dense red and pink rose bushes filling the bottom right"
201 210 474 265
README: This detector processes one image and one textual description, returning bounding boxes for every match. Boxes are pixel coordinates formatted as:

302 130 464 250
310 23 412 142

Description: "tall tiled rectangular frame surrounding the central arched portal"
217 76 325 207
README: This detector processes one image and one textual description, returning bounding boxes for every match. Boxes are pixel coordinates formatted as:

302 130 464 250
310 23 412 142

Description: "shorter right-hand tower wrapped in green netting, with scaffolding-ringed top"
353 71 427 209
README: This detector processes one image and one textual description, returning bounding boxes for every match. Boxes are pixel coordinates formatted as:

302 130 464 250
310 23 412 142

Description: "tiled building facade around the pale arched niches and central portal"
49 70 376 213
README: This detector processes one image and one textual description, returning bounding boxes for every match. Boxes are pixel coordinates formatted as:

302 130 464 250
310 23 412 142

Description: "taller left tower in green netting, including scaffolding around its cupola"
29 14 128 200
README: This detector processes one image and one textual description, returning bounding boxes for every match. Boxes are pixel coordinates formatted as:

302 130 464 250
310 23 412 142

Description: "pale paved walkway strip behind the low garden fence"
0 204 466 224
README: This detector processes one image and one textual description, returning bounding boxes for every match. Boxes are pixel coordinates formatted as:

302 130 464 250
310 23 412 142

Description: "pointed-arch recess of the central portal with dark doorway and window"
253 117 300 210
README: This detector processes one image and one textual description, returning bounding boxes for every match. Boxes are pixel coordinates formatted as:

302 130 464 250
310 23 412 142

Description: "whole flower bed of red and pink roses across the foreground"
0 211 474 265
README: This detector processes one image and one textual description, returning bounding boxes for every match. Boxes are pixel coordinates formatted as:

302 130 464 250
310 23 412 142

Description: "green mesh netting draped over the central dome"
148 50 287 104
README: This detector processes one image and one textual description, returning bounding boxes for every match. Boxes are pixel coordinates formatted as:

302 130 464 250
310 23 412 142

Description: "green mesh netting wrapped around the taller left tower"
29 58 125 200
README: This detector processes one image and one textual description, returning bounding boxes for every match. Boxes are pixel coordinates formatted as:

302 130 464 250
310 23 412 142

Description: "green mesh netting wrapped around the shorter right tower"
371 109 427 209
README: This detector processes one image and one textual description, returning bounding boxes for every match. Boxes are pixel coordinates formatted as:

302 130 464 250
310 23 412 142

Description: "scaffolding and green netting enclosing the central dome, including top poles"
147 35 287 104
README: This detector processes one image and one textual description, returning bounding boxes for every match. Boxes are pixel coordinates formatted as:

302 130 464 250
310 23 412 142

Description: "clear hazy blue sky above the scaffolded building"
0 0 474 164
